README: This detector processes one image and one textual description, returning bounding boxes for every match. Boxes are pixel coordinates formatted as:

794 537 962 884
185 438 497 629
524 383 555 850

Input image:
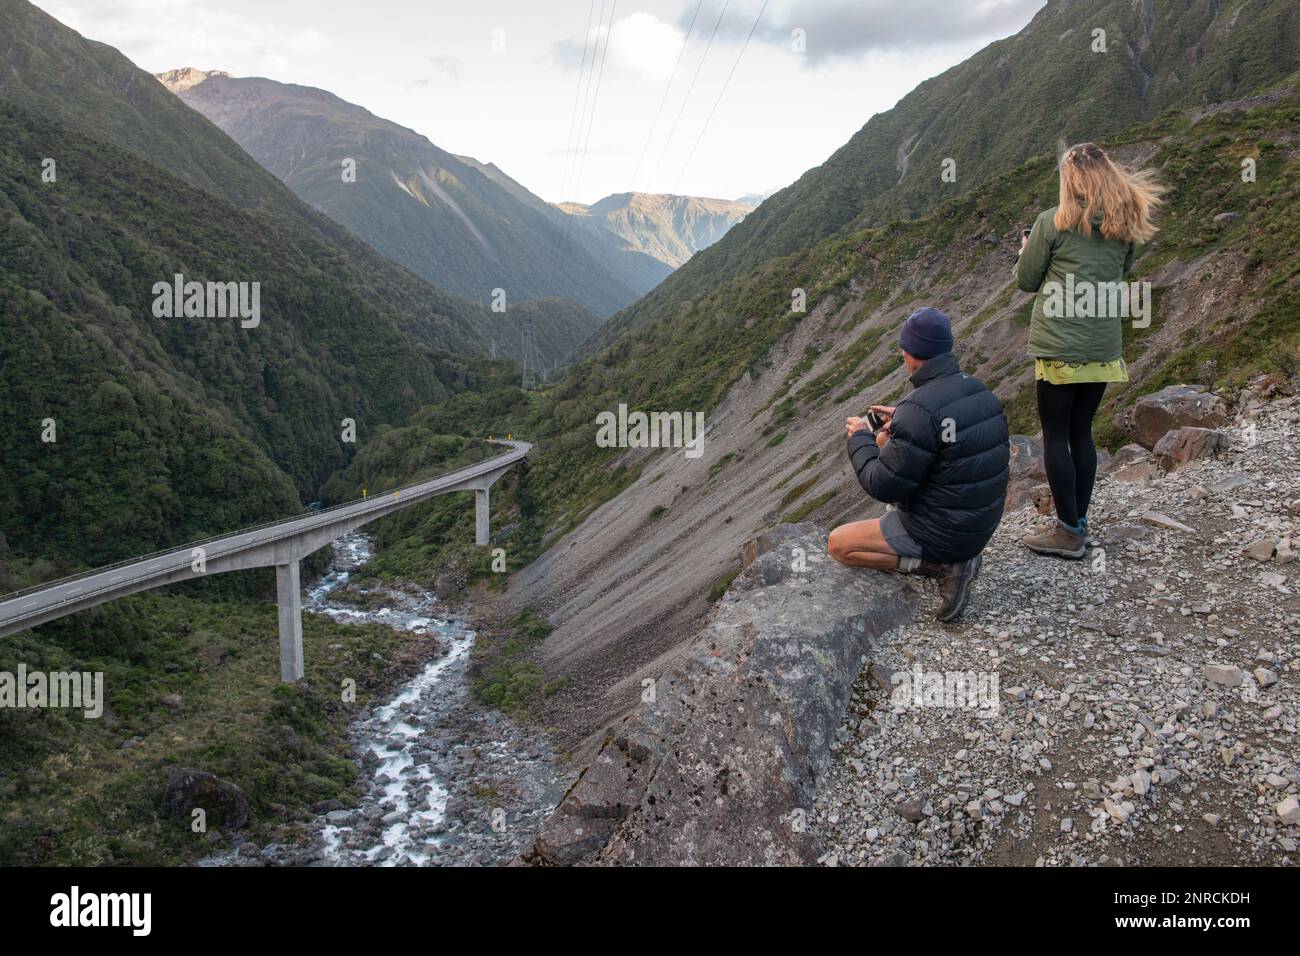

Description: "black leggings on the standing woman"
1037 380 1106 528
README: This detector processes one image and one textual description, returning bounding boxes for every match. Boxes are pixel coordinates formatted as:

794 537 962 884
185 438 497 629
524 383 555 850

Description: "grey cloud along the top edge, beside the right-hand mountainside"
677 0 1047 62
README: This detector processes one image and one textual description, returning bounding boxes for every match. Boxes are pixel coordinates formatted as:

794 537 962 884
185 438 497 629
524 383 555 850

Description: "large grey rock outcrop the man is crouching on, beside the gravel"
525 525 913 865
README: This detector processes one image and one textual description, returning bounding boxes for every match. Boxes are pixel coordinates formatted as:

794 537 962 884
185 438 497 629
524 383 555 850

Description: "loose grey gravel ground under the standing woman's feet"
811 398 1300 865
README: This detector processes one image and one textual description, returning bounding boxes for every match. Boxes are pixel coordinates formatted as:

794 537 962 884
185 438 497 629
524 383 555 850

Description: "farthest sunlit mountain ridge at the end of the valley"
559 193 757 268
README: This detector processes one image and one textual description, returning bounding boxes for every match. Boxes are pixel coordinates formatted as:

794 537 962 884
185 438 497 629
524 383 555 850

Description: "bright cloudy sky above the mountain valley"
35 0 1045 203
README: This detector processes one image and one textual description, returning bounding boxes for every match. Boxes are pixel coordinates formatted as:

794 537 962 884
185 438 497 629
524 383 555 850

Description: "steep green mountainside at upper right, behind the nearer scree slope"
598 0 1300 343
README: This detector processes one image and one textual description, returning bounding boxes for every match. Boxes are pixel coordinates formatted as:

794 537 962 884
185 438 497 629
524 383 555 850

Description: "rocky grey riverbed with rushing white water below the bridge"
204 532 563 866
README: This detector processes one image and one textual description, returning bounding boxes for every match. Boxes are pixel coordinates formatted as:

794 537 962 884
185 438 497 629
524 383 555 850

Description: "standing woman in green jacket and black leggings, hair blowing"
1015 143 1164 558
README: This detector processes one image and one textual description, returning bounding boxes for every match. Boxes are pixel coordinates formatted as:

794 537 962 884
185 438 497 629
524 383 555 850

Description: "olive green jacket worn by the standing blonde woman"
1015 206 1136 362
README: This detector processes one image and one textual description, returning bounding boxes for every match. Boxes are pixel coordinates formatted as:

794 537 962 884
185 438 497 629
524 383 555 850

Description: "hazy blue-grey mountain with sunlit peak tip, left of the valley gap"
160 70 670 316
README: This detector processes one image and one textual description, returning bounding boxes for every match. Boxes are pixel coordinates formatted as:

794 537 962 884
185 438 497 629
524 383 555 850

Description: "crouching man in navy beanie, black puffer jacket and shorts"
828 308 1010 623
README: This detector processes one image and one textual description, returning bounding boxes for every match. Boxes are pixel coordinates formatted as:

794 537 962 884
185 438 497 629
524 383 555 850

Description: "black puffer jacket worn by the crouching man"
849 352 1010 562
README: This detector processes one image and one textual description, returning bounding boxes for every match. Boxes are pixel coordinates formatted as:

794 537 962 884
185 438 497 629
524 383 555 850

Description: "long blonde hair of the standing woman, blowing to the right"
1053 143 1165 242
